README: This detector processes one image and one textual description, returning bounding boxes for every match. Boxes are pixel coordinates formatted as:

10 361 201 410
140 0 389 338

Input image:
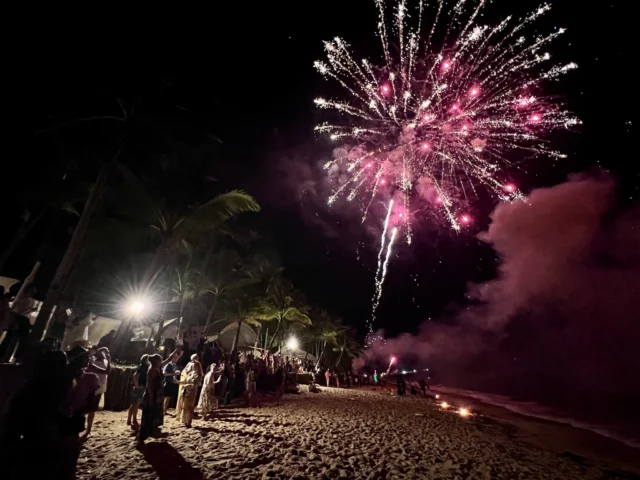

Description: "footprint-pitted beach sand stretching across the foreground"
78 386 640 480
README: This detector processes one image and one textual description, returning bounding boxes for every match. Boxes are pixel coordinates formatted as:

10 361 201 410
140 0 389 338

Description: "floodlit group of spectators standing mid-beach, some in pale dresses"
127 342 301 445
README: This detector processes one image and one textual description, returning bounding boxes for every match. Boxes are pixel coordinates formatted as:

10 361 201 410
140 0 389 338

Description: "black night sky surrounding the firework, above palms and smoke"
3 0 640 333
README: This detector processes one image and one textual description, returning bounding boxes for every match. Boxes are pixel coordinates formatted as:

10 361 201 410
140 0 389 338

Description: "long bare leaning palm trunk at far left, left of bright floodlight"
30 144 122 344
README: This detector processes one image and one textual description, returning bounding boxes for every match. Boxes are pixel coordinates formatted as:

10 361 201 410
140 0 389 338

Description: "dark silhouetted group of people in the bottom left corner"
0 343 111 479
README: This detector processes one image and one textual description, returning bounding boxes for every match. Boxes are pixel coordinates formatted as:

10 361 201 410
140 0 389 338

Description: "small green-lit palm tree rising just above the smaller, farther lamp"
253 276 312 347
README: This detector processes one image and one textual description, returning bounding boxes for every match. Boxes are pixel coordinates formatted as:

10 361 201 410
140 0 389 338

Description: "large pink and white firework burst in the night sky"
315 0 580 232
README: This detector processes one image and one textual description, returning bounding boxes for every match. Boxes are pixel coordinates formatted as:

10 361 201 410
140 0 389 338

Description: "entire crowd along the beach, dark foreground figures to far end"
0 331 384 479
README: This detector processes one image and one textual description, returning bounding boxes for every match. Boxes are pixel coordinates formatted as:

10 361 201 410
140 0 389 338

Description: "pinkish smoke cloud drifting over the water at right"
358 176 640 418
